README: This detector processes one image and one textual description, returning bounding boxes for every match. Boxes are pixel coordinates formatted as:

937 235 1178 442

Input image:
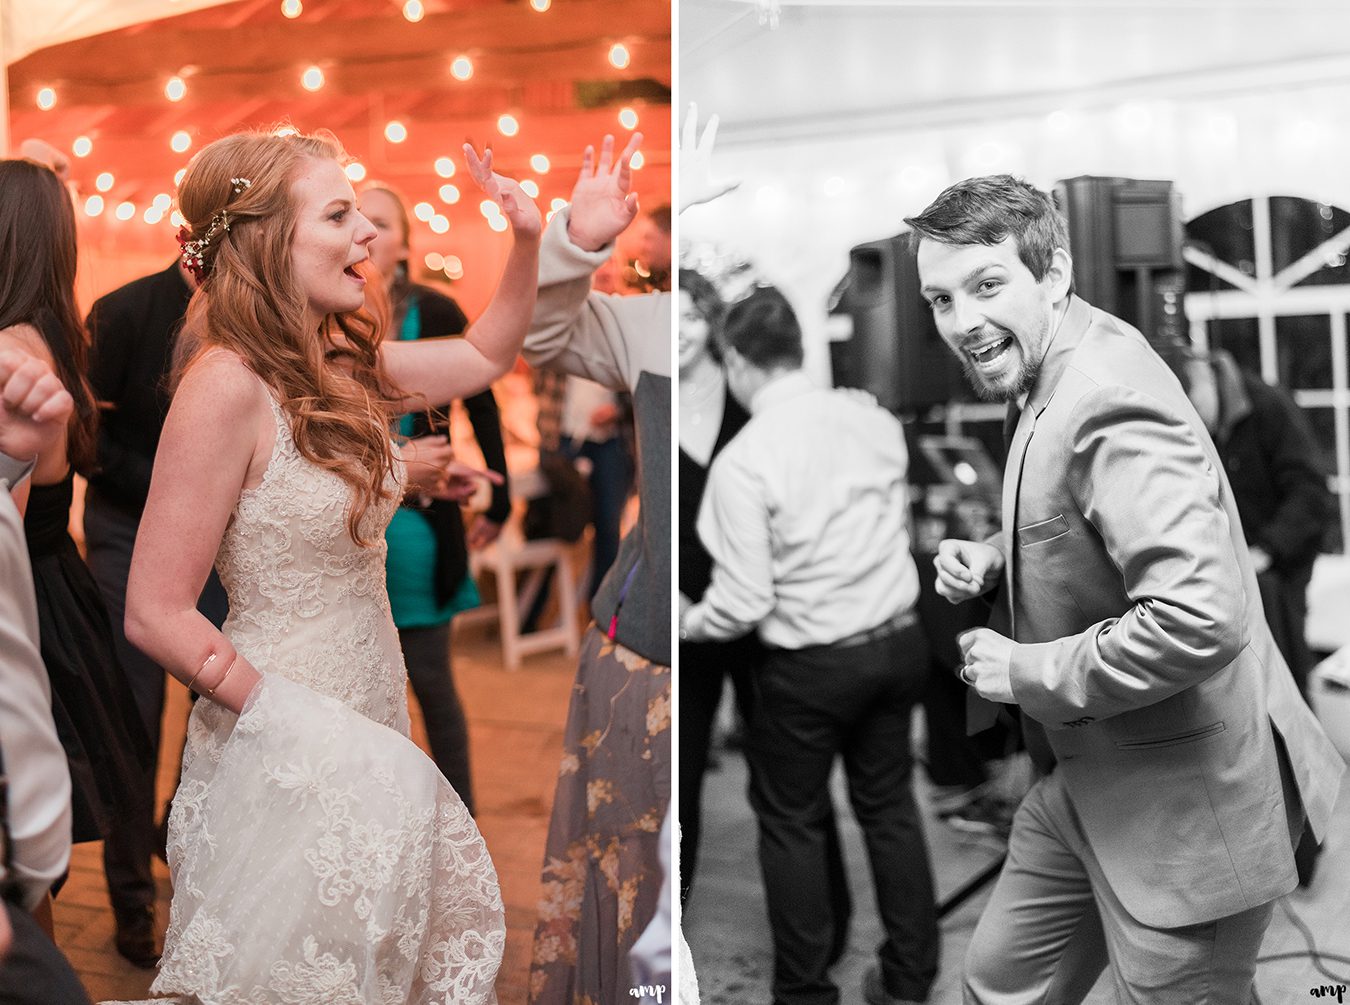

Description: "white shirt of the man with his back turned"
683 370 919 648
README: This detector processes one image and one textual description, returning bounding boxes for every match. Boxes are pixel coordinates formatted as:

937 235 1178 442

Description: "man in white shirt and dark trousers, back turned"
680 289 938 1005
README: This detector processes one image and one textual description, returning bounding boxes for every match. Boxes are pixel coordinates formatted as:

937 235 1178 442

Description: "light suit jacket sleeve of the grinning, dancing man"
1011 386 1247 723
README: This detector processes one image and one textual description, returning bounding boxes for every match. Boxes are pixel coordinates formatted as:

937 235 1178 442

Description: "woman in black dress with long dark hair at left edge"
0 161 153 902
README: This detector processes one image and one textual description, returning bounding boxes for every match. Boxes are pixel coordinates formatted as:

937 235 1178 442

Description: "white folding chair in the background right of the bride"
455 520 581 670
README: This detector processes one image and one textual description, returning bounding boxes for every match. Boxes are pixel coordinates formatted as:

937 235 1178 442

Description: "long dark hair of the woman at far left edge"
0 161 99 469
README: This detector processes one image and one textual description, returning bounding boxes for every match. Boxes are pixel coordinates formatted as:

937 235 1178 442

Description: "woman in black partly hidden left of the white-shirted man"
678 269 760 904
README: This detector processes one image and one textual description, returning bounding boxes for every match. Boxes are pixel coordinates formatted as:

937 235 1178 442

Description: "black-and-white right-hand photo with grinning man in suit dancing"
676 0 1350 1005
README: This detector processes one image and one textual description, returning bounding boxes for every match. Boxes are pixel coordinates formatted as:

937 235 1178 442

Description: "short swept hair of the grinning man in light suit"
905 174 1069 282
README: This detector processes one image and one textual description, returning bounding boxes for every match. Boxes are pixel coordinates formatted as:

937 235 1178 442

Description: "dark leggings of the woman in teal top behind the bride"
398 621 474 813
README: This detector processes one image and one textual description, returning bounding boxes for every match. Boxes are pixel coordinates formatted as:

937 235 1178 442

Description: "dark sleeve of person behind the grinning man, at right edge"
1249 388 1332 567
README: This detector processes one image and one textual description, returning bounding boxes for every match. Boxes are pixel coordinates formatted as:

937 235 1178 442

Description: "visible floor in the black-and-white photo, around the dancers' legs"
683 718 1350 1005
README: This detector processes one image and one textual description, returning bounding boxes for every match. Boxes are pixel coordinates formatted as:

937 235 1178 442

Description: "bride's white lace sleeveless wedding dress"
108 403 506 1005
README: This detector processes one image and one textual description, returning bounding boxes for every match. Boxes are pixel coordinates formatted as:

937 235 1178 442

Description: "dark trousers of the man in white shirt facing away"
749 624 940 1005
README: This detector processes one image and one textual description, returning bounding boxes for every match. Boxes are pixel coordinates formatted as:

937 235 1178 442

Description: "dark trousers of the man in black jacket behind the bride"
84 492 227 914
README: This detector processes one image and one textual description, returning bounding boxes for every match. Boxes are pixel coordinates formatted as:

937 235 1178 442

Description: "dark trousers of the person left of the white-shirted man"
678 635 764 904
